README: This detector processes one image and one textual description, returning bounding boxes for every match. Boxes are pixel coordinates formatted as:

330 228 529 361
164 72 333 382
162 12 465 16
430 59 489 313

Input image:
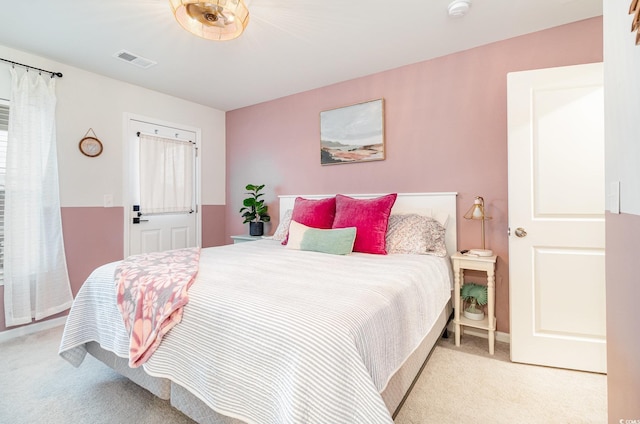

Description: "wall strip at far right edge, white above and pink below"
602 0 640 423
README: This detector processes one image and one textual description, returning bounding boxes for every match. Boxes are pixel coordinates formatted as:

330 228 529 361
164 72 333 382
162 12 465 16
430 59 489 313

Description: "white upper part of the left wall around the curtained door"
0 45 225 207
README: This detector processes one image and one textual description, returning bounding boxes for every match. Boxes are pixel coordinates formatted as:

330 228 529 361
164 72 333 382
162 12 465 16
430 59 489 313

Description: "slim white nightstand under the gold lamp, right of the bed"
451 253 498 355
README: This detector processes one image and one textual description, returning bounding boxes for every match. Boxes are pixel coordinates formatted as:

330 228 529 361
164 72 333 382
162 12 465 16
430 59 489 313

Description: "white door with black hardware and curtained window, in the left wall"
125 115 200 256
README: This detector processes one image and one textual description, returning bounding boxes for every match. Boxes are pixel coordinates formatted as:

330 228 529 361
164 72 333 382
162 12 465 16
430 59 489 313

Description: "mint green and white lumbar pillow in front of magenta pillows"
286 221 356 255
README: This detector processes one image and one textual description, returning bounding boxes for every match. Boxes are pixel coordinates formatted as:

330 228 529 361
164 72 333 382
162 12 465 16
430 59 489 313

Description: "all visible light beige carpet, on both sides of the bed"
0 328 607 424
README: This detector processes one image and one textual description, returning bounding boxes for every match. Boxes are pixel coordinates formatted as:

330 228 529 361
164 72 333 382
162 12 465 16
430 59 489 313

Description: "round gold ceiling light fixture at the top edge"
169 0 249 41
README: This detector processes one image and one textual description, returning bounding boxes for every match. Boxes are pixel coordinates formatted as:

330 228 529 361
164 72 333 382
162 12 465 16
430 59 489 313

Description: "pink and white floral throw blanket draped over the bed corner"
115 247 200 368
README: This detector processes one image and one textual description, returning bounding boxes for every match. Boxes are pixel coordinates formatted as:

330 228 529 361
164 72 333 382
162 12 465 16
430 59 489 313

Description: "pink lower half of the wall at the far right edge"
606 213 640 423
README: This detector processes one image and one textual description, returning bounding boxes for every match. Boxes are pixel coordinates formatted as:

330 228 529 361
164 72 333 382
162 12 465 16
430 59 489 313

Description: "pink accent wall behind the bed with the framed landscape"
225 17 603 332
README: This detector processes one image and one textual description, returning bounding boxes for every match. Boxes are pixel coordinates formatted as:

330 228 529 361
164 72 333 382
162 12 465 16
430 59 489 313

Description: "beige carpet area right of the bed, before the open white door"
395 335 607 424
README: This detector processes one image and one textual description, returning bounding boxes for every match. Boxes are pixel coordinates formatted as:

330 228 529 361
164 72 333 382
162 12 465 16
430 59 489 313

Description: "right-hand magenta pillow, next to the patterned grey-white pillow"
333 193 398 255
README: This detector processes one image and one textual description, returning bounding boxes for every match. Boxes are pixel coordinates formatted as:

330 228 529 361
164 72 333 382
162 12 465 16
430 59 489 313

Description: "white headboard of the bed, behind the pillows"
278 193 458 255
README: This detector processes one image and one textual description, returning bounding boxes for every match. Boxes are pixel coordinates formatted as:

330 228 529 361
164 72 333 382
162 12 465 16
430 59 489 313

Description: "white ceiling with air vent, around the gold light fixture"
0 0 602 111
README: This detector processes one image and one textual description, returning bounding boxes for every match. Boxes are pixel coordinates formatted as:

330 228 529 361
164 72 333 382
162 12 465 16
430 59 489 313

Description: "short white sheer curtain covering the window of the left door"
140 134 195 214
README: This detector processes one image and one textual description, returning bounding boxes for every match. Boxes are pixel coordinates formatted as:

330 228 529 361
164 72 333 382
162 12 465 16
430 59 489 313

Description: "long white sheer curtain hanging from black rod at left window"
4 68 73 326
